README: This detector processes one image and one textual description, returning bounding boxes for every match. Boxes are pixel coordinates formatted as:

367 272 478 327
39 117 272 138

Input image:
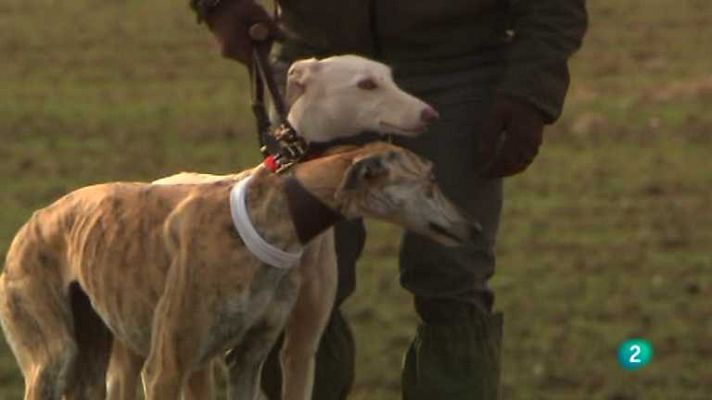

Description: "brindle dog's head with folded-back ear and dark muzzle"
335 143 481 245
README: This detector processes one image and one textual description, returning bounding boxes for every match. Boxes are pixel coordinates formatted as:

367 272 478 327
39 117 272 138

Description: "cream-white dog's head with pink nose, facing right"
287 55 438 142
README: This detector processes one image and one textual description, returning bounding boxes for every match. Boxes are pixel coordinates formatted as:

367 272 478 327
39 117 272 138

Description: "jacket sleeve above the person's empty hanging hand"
499 0 588 123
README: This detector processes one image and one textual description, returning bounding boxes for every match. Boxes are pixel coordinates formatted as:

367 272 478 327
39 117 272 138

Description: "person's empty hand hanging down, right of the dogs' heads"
479 94 544 178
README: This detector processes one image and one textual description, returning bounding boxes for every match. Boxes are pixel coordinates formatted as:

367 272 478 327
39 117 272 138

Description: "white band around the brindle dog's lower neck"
230 176 302 269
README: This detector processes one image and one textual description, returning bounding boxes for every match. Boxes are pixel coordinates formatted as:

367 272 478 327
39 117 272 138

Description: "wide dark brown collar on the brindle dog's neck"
284 176 345 244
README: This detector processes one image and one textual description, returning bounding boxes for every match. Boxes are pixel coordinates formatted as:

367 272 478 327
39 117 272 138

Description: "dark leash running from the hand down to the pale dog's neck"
249 23 309 174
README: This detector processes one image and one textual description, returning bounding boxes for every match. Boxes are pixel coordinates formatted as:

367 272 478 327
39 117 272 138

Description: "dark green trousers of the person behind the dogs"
263 57 503 400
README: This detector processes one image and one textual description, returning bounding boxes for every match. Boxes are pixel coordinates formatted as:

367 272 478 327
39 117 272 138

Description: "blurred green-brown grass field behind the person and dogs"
0 0 712 400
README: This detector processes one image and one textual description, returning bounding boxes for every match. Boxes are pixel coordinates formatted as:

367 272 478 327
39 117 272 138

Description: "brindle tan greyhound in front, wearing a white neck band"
0 143 475 400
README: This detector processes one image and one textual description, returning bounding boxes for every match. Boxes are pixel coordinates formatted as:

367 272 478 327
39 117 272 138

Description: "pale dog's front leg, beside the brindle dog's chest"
281 230 338 400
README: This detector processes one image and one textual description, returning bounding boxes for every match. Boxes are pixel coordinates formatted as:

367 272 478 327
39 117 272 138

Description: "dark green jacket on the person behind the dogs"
278 0 587 121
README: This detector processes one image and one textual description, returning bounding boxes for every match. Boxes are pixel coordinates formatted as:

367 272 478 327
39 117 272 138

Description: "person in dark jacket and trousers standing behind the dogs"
191 0 588 400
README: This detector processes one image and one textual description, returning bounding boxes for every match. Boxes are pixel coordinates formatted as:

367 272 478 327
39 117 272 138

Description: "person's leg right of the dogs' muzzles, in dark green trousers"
398 67 502 400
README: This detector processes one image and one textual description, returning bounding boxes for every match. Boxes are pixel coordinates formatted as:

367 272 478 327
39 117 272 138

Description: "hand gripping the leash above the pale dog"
205 0 279 65
